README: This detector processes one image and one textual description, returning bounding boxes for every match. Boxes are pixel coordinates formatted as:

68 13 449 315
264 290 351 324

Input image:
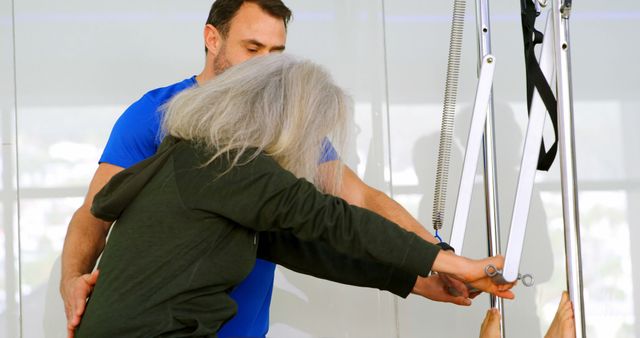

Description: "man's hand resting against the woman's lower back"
60 270 99 338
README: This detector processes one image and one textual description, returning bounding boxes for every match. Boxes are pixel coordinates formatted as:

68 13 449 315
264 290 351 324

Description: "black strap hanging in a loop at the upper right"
520 0 558 171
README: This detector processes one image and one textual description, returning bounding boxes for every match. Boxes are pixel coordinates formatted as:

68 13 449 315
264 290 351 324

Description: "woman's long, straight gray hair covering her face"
162 54 352 192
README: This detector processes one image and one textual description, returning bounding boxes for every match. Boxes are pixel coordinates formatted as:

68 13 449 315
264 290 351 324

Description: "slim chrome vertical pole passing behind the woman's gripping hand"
476 0 505 337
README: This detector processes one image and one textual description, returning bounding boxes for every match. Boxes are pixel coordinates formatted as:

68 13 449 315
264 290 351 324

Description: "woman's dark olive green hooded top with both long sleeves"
76 137 439 338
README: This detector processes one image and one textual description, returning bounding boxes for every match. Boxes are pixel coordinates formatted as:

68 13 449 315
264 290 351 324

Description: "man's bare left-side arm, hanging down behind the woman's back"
60 163 123 334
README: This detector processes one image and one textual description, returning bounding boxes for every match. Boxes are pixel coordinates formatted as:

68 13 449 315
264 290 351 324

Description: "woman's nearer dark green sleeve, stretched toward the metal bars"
176 151 439 276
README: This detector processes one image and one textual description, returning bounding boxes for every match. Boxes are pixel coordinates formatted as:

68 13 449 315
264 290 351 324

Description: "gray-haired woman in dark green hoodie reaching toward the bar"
76 55 513 337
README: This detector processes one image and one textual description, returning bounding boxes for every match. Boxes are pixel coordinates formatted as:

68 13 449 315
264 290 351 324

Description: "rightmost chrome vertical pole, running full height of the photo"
551 0 586 338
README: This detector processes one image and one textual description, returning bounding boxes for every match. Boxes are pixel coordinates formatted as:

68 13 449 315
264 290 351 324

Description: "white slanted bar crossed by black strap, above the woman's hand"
503 16 555 282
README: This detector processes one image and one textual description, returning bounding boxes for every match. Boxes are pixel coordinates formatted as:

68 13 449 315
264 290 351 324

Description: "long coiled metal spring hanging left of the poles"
433 0 467 230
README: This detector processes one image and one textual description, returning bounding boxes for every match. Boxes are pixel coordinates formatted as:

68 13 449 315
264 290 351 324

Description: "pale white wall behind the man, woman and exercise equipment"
0 0 640 338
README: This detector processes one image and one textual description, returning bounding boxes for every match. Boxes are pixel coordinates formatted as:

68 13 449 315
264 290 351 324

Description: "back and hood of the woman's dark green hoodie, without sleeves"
76 142 256 337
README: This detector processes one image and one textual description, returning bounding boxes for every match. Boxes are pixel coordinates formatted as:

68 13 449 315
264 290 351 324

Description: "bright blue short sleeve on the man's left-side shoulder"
100 76 197 168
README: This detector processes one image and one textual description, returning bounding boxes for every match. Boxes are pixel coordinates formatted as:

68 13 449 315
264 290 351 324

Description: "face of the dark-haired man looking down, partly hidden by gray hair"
213 2 287 75
